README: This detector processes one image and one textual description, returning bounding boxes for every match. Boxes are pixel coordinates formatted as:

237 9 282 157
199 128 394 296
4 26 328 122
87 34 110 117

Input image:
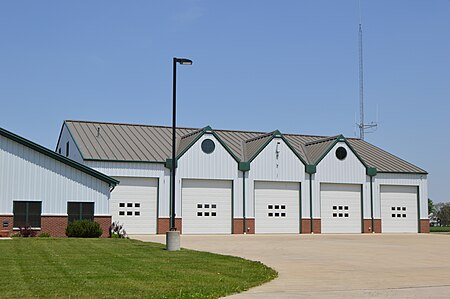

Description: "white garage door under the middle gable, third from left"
255 182 300 234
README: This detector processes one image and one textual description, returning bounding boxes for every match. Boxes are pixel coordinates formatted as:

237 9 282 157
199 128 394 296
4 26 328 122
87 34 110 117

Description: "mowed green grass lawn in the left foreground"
0 238 277 298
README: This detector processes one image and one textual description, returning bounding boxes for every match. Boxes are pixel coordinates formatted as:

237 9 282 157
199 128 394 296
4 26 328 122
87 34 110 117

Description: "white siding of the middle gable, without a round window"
246 138 309 217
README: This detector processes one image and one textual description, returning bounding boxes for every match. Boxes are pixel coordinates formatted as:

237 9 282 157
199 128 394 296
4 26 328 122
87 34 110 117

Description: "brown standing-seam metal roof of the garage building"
65 120 426 173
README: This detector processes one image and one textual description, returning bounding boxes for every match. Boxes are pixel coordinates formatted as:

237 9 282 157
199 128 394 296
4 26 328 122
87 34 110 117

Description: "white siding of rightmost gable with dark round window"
312 142 370 218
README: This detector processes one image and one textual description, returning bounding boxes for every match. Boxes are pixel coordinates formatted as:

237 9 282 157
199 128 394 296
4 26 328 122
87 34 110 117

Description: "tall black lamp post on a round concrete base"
166 57 192 251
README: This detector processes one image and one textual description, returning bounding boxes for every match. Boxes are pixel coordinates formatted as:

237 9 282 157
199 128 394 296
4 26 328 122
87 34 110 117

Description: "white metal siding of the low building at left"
0 136 110 215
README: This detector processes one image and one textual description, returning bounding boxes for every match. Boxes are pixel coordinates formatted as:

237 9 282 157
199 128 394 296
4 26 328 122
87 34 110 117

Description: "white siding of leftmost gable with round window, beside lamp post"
176 133 242 222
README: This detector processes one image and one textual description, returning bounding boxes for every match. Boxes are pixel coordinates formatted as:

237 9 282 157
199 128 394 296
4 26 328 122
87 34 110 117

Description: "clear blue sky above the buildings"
0 0 450 202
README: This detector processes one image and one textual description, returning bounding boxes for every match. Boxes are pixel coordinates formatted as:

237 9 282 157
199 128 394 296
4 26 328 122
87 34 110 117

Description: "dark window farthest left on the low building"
13 201 42 227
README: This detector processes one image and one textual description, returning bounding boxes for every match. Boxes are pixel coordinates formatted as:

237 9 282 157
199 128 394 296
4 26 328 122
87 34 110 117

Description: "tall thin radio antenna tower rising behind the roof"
356 0 378 140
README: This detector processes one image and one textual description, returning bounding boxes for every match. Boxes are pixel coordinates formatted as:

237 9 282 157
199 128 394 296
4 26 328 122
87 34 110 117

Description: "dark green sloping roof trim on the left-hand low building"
0 128 119 186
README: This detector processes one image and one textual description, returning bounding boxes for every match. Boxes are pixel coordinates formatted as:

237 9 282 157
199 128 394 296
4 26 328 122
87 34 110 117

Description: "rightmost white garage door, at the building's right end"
380 186 418 233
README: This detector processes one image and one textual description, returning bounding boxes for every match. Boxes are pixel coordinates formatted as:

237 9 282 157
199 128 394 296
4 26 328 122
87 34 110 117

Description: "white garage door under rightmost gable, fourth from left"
320 184 361 233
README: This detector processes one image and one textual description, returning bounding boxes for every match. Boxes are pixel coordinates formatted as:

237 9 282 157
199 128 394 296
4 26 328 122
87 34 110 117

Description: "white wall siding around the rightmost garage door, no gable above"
374 173 428 219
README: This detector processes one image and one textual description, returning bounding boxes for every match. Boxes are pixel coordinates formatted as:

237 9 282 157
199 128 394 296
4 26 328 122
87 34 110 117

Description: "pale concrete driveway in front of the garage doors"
133 234 450 298
